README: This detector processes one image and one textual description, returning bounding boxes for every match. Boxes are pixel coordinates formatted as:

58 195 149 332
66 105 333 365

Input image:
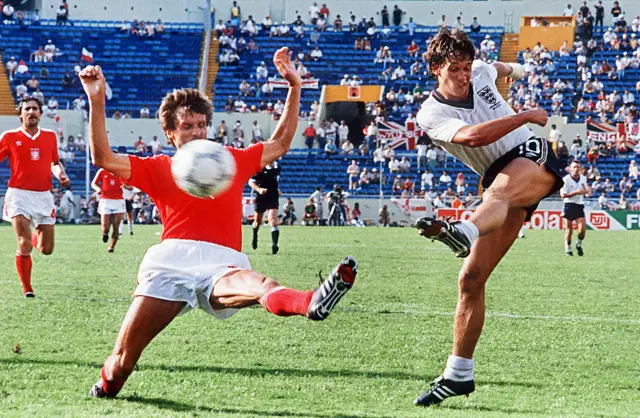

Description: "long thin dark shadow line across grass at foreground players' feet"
0 356 544 389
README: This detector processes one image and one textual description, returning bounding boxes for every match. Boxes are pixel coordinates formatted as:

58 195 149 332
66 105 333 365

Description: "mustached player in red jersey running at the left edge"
0 97 69 298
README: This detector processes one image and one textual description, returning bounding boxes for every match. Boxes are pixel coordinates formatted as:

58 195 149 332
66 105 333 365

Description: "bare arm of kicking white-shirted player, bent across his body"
451 109 548 147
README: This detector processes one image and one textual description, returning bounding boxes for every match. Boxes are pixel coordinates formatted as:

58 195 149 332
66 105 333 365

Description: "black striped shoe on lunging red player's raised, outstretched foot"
307 256 358 321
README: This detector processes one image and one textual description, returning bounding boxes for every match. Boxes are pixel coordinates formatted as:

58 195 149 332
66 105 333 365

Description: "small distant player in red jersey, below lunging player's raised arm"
91 168 125 253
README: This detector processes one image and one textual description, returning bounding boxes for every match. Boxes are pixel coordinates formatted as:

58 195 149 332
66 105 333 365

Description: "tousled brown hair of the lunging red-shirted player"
160 88 213 131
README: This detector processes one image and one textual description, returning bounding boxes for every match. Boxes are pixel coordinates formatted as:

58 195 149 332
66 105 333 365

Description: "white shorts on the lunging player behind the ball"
133 239 251 319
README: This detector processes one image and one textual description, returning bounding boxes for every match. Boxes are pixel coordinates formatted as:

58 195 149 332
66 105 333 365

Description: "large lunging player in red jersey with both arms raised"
80 48 357 397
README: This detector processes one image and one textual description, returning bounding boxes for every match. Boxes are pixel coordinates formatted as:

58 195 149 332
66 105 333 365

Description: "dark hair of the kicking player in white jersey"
427 28 476 76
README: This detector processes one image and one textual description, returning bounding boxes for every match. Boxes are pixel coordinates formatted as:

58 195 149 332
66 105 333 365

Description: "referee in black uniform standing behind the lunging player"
249 162 280 254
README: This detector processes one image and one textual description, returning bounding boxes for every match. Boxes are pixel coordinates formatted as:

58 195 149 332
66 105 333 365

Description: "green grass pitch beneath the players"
0 224 640 418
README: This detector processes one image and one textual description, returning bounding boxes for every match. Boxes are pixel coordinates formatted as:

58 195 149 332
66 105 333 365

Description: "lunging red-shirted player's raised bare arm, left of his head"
79 65 131 180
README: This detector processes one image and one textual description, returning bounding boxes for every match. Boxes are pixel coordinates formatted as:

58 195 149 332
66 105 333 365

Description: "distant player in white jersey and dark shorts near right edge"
560 160 591 256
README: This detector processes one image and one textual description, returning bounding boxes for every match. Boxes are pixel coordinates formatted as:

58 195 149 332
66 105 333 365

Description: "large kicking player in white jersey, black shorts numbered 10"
414 29 562 406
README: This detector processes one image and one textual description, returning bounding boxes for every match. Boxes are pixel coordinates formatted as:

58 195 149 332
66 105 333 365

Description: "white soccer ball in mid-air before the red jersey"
171 140 236 198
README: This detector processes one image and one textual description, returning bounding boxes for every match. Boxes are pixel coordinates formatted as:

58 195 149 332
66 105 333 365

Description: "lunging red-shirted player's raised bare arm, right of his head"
261 47 302 167
